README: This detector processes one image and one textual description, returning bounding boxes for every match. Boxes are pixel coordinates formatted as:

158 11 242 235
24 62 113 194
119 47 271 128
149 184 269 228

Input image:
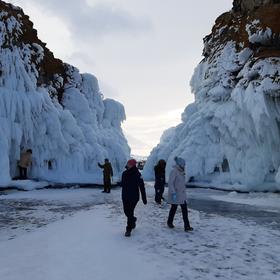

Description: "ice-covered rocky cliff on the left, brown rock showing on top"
0 1 130 186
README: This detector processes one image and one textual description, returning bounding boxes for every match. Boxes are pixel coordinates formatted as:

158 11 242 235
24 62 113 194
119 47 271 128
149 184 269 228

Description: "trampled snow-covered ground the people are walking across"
0 184 280 280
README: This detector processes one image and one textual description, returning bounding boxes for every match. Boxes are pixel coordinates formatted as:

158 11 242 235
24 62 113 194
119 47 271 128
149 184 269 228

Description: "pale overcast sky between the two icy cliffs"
10 0 232 155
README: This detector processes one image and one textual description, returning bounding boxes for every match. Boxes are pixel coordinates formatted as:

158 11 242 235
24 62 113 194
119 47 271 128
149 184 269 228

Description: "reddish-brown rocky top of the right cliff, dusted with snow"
208 0 280 58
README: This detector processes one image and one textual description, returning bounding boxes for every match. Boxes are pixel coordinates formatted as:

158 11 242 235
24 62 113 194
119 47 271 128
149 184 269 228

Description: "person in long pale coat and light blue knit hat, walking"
167 157 193 231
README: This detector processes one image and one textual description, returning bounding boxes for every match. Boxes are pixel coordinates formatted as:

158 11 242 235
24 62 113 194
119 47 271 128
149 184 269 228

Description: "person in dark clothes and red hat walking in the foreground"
121 159 147 237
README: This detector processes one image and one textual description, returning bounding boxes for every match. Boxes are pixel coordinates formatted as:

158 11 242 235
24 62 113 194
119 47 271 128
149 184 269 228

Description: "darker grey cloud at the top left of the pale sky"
23 0 152 42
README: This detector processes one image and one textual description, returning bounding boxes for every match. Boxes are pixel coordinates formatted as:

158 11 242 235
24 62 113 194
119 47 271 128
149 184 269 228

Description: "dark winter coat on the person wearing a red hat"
121 167 147 204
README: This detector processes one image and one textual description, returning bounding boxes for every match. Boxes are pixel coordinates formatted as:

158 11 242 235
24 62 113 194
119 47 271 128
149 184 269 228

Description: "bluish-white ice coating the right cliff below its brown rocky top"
143 34 280 192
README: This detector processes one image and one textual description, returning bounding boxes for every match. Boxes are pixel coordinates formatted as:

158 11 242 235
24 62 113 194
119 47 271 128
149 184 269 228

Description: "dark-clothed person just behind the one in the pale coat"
154 159 166 204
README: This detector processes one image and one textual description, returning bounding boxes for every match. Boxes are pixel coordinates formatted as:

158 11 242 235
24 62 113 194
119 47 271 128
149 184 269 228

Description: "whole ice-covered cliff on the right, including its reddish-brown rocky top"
144 0 280 190
